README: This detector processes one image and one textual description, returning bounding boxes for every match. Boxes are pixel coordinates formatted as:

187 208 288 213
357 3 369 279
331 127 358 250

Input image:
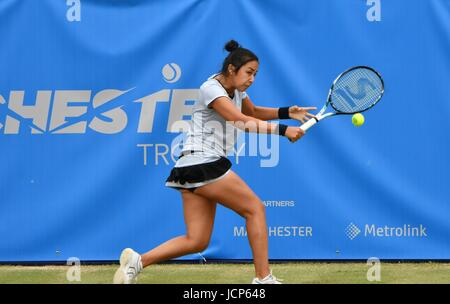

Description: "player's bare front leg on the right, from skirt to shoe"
195 171 270 278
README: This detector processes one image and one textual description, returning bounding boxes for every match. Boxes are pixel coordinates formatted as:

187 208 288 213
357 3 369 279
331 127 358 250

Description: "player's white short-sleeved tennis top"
175 74 247 167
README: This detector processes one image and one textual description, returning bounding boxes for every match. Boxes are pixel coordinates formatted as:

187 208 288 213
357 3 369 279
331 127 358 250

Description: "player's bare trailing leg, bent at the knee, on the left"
141 189 216 267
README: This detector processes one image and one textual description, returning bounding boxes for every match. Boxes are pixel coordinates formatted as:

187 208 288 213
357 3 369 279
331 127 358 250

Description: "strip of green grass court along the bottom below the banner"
0 262 450 284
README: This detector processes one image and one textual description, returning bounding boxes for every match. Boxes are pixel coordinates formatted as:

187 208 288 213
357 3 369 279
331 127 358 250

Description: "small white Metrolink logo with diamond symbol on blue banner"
345 223 428 240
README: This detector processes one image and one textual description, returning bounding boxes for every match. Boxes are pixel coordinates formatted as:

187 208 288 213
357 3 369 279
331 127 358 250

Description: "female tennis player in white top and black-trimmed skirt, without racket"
114 40 316 284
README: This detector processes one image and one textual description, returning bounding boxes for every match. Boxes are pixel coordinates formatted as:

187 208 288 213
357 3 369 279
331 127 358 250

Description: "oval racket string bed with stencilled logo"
331 68 384 113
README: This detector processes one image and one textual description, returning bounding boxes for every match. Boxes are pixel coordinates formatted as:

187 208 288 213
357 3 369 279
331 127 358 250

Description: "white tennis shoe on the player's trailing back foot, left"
114 248 143 284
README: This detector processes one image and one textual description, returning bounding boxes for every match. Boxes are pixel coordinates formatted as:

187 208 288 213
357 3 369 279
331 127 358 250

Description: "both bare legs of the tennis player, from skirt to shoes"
141 171 270 278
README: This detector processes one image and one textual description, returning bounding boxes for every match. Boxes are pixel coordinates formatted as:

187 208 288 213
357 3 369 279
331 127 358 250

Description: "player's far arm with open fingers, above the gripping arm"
242 96 317 123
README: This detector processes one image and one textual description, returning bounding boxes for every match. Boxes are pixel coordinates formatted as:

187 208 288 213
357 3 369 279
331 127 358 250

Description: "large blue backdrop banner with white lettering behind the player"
0 0 450 262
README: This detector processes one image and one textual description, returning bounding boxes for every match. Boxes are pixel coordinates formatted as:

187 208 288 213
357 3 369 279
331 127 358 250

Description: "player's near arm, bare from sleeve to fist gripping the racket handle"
209 96 305 142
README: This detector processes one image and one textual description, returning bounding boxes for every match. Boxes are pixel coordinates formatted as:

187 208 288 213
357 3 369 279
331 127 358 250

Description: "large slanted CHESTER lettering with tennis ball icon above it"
0 63 194 134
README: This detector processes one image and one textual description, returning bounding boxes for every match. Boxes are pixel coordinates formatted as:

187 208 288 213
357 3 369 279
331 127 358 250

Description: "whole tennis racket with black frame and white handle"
300 66 384 131
